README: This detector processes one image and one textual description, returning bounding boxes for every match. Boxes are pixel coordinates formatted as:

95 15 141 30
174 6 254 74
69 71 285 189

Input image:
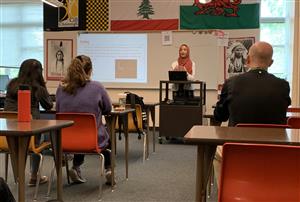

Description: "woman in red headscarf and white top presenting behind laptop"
171 44 196 97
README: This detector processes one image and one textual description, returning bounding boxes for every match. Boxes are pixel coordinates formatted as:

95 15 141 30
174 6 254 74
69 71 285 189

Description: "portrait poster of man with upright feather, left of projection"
46 39 73 81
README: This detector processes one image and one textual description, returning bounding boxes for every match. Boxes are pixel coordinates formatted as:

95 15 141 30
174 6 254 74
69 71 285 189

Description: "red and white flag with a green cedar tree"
110 0 193 31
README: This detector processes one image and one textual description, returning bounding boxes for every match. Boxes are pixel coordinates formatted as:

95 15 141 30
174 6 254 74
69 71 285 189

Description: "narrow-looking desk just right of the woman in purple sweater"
105 109 135 190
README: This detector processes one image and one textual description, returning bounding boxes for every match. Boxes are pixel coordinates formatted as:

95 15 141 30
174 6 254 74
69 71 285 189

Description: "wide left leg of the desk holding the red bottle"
7 136 30 202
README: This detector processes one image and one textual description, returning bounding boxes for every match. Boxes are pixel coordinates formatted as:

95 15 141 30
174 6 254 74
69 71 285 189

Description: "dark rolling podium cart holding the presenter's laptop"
159 81 206 143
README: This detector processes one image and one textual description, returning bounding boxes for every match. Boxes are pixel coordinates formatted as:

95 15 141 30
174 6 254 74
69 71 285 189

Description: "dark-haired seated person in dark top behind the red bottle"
4 59 53 186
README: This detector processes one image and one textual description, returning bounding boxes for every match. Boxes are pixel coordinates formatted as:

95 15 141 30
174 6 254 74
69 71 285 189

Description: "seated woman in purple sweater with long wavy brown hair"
56 55 112 183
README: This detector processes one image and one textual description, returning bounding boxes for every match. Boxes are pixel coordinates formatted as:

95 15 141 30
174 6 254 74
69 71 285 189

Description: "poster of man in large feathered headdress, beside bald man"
224 37 255 80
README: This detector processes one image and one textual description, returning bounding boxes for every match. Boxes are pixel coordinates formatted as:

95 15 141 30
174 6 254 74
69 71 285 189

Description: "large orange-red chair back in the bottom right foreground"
219 143 300 202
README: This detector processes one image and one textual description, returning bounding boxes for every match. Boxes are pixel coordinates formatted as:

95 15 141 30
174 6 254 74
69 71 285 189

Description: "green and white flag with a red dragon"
180 0 260 29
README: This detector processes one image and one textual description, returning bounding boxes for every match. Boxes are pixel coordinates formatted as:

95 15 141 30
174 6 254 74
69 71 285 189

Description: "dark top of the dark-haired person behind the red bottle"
4 79 53 119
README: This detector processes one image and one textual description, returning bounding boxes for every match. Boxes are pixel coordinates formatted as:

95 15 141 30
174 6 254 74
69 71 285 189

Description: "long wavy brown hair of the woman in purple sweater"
62 55 92 95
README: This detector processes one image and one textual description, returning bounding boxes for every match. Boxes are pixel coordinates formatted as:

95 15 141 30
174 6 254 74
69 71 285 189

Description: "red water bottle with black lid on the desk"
18 85 31 122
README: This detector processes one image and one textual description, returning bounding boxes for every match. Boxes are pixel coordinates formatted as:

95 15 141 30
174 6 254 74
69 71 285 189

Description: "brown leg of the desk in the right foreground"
196 144 216 202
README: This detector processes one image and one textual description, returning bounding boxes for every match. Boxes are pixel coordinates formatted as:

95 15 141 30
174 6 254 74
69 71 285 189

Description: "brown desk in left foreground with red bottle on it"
0 119 73 202
